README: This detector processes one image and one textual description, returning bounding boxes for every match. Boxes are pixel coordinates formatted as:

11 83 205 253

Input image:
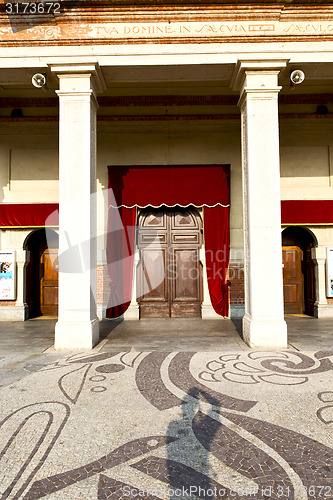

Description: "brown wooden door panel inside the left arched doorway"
40 248 59 316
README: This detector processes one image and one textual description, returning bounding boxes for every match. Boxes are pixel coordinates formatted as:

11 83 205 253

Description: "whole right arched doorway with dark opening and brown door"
282 226 316 316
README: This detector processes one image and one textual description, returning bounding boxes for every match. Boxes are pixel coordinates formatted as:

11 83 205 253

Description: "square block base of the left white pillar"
54 318 99 349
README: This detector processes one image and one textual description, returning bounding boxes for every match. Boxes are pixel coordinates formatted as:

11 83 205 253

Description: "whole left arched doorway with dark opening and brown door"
25 229 59 318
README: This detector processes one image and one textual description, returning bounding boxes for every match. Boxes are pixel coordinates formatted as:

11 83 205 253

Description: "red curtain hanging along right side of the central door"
204 205 230 316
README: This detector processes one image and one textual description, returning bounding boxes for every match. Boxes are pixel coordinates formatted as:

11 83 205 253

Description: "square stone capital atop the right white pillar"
230 59 289 91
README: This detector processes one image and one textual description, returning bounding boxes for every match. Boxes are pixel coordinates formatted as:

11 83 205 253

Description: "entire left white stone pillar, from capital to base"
51 63 104 349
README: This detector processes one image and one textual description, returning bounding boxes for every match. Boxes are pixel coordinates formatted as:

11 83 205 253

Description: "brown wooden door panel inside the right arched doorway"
282 246 304 314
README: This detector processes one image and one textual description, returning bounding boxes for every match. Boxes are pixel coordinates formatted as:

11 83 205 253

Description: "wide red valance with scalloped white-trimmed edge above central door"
109 165 230 208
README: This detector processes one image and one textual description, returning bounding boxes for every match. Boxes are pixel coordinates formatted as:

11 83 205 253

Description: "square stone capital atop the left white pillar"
49 62 106 94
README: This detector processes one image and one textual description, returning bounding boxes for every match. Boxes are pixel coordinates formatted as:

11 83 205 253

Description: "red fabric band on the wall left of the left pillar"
0 203 59 228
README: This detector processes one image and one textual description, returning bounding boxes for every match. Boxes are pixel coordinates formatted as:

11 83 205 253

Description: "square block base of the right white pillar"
243 315 288 348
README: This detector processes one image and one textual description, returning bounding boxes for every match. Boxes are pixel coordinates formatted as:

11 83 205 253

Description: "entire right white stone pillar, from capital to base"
234 61 287 347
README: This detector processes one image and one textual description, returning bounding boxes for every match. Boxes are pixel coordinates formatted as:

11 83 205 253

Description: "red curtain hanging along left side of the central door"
106 207 136 318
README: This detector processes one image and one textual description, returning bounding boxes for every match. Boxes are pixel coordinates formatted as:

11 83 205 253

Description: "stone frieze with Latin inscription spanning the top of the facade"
0 17 333 46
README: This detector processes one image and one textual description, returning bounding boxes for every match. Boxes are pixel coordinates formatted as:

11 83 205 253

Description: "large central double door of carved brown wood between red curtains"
137 207 202 318
